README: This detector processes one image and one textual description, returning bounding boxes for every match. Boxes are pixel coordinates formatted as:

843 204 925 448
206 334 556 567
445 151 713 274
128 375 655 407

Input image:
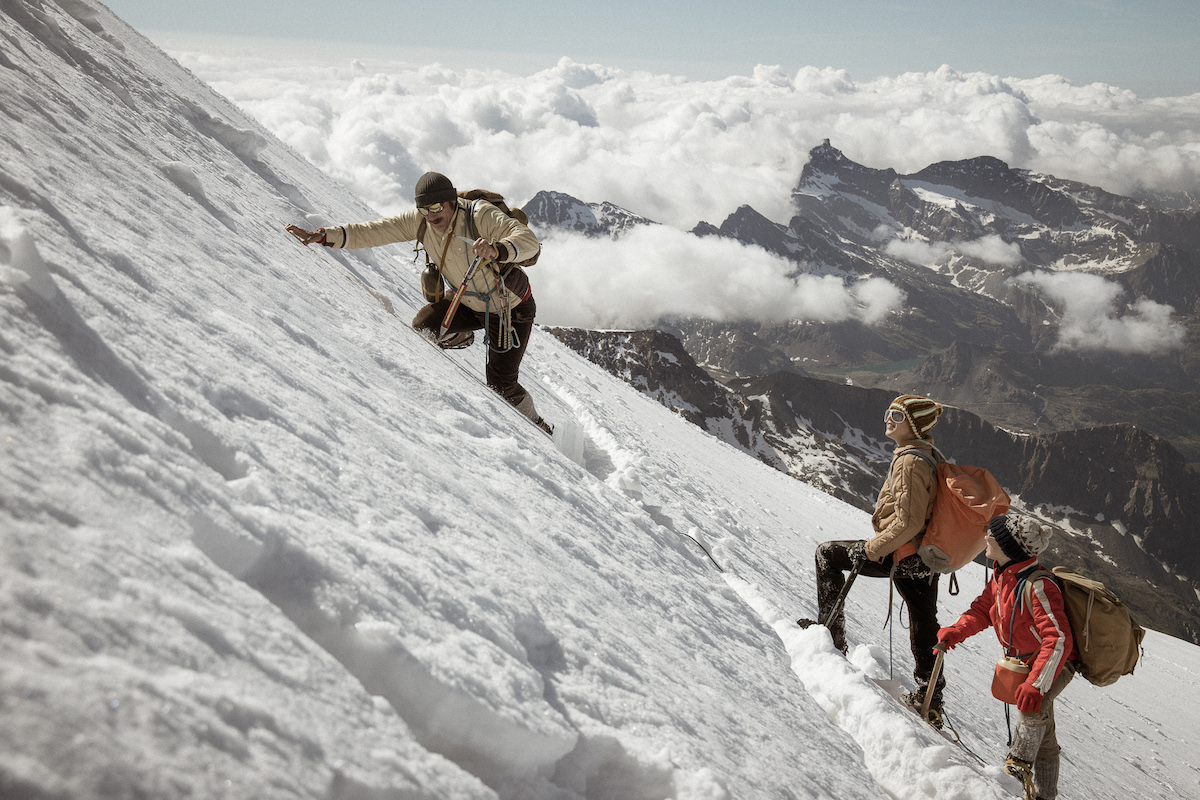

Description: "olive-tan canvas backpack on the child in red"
1024 566 1146 686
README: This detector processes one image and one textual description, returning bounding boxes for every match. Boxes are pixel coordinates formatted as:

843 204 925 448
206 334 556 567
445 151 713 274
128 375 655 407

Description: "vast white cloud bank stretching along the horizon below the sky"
168 43 1200 228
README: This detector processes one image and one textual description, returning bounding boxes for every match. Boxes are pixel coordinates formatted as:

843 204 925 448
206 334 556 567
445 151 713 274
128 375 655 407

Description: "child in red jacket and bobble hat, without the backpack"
937 516 1079 800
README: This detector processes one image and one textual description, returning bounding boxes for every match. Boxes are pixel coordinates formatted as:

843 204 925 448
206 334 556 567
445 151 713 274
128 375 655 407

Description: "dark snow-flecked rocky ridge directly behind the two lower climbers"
547 329 1200 643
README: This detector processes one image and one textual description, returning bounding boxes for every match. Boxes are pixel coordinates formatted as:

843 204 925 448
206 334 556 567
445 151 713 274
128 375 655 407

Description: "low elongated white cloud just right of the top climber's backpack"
533 225 905 329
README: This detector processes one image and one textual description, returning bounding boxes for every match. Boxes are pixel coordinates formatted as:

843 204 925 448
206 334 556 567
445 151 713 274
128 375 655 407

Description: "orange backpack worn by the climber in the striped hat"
900 447 1009 573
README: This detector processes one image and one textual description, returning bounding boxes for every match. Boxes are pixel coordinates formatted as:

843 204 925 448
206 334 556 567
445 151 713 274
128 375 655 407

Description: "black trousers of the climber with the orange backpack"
816 541 946 705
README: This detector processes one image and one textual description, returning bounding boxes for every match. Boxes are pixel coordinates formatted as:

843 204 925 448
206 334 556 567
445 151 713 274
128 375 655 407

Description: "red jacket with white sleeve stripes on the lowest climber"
950 558 1079 694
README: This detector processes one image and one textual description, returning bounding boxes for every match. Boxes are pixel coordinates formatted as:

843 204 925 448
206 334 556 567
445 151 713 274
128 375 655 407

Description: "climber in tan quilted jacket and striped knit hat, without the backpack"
798 395 946 728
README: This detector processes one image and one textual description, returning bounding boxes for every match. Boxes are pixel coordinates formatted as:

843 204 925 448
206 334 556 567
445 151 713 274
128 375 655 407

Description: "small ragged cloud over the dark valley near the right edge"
1013 270 1187 355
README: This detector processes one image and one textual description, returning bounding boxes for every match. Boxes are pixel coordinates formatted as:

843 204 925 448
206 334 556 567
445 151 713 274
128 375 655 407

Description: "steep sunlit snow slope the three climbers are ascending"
0 6 1200 800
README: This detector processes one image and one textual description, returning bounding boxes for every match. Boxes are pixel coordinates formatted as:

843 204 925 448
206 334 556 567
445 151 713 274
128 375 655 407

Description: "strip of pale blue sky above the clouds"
107 0 1200 96
